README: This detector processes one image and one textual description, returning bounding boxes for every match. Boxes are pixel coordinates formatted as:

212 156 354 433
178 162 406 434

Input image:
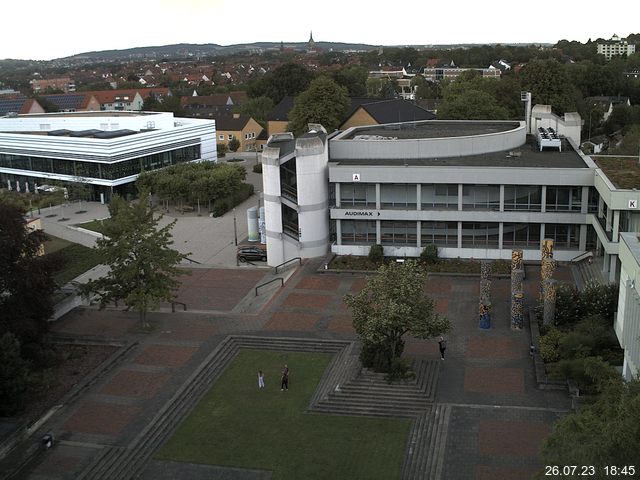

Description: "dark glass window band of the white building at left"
0 145 200 180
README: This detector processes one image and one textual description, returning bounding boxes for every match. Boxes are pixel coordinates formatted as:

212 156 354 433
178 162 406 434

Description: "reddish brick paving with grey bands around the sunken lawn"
13 260 569 480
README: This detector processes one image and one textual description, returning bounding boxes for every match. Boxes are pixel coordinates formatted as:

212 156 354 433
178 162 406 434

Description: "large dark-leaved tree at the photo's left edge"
0 197 60 352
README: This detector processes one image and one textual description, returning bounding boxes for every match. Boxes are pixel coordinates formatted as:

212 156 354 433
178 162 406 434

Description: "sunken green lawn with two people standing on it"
155 350 411 480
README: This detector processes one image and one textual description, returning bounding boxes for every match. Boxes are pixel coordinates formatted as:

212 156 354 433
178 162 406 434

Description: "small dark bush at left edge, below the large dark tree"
0 332 29 417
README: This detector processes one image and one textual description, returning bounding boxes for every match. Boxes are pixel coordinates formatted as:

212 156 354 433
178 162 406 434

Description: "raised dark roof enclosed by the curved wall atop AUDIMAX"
339 120 520 141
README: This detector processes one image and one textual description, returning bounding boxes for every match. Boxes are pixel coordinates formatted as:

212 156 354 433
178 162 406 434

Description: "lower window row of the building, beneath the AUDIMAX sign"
340 220 580 249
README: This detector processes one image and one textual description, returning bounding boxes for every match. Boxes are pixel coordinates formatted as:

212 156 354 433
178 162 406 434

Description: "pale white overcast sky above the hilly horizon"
0 0 640 60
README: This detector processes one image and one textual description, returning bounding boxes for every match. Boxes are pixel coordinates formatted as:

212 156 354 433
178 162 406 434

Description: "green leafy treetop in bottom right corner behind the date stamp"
538 371 640 472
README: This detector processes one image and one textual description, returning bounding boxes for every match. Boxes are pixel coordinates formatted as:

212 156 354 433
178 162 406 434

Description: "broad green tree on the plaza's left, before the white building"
83 190 185 327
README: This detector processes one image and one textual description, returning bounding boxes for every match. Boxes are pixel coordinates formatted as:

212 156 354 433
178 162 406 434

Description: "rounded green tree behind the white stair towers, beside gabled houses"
288 77 350 135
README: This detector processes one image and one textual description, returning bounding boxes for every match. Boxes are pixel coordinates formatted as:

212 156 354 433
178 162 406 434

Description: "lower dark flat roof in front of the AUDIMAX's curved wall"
329 135 589 168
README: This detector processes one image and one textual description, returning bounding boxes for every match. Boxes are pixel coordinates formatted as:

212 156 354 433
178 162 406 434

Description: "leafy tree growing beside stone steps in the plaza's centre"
344 260 451 369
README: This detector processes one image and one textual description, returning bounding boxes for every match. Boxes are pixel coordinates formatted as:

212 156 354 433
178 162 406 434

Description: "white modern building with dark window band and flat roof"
0 112 217 200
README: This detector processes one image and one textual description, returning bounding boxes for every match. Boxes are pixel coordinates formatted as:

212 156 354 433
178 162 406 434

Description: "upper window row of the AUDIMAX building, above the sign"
332 183 598 212
